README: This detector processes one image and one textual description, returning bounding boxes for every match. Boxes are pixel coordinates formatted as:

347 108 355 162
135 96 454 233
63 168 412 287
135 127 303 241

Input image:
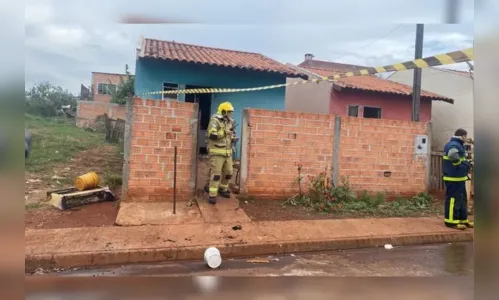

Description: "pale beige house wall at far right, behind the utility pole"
388 68 474 151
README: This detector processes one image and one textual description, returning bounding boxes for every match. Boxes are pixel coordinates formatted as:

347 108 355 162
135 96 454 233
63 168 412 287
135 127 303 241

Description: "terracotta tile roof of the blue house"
140 39 306 78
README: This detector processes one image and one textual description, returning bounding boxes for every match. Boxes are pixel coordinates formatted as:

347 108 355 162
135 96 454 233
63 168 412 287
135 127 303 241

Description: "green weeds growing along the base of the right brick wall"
284 164 439 217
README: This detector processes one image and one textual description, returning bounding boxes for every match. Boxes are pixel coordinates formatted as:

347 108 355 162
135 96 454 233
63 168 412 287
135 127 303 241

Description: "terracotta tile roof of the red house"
306 68 454 103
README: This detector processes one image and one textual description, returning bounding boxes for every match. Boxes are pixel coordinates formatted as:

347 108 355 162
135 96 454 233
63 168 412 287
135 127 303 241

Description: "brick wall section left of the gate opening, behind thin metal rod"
124 98 197 202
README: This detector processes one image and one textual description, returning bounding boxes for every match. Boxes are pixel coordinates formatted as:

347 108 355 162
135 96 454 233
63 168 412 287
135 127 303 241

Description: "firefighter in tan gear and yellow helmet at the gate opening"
206 102 237 204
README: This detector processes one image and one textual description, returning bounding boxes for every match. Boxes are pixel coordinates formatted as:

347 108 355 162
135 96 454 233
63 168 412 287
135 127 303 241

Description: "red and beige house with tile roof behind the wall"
286 54 453 122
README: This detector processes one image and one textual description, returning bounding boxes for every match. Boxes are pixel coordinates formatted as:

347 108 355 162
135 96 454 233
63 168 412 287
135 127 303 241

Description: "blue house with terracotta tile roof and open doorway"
135 39 307 156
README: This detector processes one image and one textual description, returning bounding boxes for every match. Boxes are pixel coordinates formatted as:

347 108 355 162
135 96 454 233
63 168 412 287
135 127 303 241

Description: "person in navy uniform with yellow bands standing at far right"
442 129 474 230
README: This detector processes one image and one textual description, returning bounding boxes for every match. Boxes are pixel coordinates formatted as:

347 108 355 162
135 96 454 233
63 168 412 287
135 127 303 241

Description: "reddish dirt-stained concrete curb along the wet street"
25 231 473 272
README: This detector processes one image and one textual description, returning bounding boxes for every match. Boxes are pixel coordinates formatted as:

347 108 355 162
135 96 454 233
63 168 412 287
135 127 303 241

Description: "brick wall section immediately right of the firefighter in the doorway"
243 109 334 199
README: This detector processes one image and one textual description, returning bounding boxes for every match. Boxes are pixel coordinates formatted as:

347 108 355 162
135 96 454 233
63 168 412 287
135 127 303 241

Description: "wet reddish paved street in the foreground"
26 243 474 300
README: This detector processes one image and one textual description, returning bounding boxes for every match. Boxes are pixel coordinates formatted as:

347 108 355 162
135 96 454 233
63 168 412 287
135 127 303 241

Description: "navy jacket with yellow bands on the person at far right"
442 137 471 182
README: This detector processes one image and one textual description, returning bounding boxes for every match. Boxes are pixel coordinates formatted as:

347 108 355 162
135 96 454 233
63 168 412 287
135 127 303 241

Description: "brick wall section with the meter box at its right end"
338 117 428 196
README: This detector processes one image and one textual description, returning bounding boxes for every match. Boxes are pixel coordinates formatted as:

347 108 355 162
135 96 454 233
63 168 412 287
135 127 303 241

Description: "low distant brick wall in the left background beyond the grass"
76 100 126 128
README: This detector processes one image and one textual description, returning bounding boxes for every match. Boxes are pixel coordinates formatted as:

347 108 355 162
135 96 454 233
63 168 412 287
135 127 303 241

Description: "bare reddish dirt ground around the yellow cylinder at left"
25 145 123 229
